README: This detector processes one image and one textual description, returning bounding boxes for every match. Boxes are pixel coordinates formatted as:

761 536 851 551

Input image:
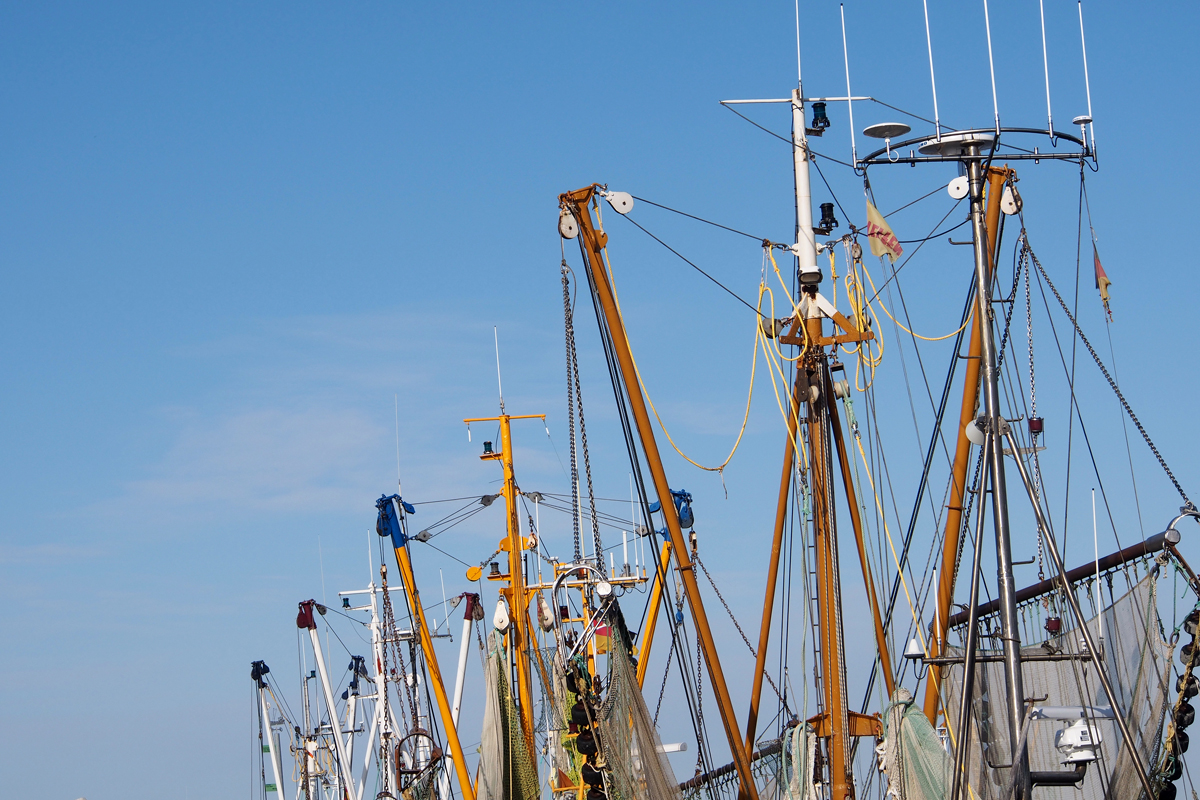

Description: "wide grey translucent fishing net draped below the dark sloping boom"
943 572 1174 800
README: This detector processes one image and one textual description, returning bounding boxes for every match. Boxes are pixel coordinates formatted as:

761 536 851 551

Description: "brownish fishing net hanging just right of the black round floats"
599 646 683 800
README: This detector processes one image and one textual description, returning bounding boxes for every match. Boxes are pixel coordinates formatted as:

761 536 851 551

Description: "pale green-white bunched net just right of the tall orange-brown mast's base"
875 688 954 800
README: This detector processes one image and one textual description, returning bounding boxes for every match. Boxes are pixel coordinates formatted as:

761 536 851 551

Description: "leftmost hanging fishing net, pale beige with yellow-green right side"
476 631 539 800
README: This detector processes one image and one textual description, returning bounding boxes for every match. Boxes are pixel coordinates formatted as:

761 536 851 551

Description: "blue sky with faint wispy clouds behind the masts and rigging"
0 0 1200 800
